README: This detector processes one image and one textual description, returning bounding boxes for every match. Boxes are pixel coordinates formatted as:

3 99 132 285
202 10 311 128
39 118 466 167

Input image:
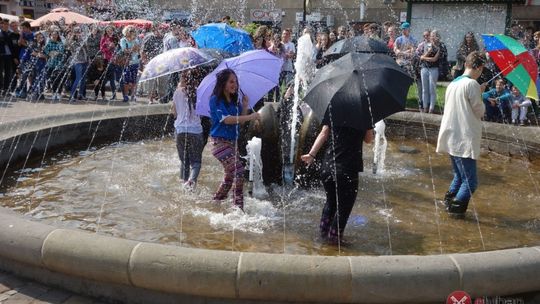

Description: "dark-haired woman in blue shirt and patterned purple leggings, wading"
210 69 260 210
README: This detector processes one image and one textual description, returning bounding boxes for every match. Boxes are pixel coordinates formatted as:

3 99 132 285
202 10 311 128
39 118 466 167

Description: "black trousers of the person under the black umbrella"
320 174 358 241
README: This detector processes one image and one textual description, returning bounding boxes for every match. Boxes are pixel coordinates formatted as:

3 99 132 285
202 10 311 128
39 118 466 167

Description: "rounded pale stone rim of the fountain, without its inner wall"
0 105 540 303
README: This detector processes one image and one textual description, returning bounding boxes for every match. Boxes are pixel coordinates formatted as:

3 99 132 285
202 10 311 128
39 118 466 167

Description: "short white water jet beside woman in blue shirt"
246 137 268 199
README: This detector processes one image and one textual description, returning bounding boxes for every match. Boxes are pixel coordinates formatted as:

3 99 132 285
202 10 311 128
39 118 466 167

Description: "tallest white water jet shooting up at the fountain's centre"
283 33 315 185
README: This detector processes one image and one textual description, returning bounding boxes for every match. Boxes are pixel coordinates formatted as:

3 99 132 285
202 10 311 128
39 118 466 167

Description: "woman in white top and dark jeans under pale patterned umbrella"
172 72 204 187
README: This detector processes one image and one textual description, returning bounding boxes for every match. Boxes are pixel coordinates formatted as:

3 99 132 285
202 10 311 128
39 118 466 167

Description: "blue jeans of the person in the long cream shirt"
448 156 478 203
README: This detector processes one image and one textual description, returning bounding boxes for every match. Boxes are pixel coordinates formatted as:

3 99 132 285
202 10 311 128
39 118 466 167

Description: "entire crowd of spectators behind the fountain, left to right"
0 16 540 124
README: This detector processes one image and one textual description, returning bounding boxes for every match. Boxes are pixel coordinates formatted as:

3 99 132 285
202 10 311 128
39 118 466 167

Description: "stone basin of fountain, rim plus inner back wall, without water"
0 105 540 303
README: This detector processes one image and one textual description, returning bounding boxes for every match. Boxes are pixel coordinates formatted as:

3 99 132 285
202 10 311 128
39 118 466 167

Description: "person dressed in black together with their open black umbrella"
301 53 413 245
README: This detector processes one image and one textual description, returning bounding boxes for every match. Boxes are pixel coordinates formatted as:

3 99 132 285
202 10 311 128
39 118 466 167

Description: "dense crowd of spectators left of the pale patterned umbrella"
0 16 195 102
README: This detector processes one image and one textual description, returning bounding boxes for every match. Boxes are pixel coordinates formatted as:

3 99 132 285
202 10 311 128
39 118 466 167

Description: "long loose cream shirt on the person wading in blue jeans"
437 76 486 159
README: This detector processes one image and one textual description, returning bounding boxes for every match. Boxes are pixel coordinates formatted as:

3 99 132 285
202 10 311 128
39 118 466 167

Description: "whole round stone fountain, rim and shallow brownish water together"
0 105 540 303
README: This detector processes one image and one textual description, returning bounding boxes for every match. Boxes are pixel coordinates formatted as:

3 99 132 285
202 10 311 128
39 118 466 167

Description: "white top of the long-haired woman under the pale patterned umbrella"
173 89 203 134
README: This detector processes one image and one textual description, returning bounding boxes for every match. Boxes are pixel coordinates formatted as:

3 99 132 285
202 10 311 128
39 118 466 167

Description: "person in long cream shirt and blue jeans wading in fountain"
436 51 486 216
